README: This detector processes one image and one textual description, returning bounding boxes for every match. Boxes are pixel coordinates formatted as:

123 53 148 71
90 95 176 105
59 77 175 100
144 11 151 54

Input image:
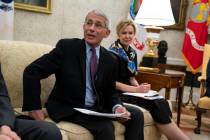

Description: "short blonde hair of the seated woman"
116 19 136 36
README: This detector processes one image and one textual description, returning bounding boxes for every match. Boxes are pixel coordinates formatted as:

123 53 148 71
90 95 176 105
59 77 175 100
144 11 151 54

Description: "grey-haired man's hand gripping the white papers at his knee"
115 106 131 123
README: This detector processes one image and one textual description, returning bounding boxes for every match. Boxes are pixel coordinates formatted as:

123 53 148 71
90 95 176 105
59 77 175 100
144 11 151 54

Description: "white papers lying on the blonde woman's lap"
123 90 163 100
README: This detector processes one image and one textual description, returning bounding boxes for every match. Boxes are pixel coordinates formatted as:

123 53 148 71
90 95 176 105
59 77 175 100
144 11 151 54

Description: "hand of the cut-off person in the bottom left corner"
0 125 21 140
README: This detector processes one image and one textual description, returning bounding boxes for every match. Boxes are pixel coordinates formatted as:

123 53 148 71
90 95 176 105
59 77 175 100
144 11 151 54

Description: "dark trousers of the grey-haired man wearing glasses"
64 106 144 140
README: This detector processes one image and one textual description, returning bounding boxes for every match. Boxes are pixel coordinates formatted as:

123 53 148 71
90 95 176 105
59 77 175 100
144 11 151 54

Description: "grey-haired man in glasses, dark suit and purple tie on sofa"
23 10 144 140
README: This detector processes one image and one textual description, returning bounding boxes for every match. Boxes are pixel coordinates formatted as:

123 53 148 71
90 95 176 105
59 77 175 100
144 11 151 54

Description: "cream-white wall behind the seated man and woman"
14 0 210 65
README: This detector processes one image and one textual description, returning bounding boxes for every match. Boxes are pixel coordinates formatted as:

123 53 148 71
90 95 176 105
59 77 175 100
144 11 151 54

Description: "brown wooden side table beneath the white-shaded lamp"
136 70 185 126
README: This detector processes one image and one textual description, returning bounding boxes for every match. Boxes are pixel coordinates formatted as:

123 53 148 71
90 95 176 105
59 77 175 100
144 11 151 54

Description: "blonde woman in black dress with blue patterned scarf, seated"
109 20 189 140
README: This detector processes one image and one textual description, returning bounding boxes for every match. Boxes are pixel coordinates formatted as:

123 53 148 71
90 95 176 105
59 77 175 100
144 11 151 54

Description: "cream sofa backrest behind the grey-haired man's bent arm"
0 40 55 108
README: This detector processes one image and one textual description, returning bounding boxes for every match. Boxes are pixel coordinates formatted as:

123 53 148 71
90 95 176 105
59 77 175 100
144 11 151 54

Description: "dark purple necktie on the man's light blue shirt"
90 48 98 84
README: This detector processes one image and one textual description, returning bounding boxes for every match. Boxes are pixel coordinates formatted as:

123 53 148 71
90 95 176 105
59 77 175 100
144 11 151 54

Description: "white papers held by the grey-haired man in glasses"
74 108 124 118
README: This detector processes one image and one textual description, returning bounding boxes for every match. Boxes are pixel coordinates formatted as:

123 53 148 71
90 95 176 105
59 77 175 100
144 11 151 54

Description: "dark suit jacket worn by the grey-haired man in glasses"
23 39 121 121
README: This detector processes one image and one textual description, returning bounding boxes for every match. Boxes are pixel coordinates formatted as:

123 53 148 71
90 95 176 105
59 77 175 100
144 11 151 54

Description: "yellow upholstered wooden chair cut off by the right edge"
194 44 210 134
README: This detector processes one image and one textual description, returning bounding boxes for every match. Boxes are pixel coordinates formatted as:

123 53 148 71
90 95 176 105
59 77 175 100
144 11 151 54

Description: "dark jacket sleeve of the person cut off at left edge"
0 70 15 128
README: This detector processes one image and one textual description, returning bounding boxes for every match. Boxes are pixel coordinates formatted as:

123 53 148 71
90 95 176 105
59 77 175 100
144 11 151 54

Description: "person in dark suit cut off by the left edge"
0 67 62 140
